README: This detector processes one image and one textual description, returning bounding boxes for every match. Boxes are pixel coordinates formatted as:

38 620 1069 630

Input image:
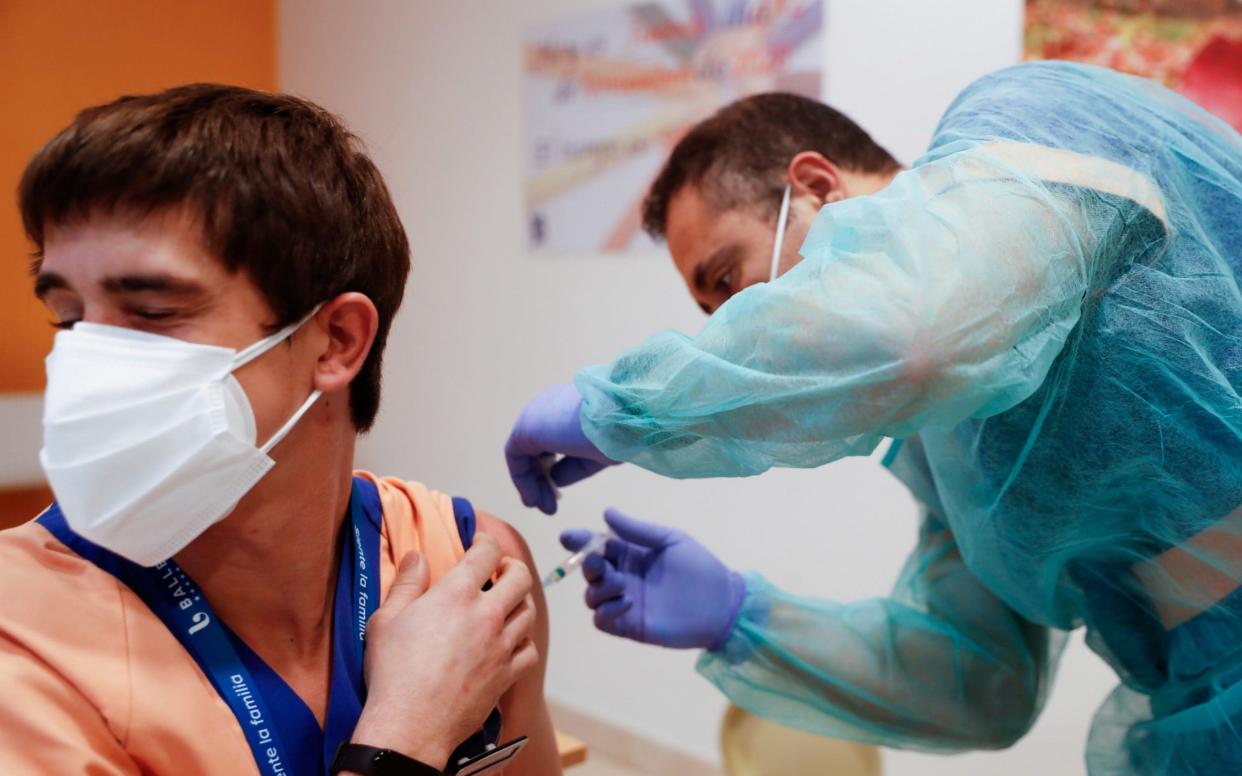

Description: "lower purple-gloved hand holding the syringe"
560 509 746 649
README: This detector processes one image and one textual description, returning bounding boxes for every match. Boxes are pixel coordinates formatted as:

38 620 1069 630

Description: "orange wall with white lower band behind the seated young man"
0 0 276 526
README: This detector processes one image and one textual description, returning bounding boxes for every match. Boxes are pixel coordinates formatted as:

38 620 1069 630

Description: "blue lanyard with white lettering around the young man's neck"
39 477 383 776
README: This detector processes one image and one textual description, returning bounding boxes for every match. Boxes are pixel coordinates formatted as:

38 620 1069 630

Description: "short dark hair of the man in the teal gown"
642 92 900 240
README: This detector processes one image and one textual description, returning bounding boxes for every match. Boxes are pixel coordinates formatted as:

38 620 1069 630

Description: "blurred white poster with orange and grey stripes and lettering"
524 0 823 253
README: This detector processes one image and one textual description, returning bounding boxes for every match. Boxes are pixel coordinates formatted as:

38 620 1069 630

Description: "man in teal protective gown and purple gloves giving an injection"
505 62 1242 774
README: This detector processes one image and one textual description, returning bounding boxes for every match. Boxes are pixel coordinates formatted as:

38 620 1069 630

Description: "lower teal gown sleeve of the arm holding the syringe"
698 440 1066 752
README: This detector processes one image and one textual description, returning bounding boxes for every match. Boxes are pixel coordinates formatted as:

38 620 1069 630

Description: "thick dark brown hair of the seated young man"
19 83 410 431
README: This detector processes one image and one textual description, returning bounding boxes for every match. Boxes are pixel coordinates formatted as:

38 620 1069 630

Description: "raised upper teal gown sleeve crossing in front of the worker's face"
576 142 1159 477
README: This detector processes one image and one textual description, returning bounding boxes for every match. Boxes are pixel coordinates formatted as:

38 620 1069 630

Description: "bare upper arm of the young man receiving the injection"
477 512 560 776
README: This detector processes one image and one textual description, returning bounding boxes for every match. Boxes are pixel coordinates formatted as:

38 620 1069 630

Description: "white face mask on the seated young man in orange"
39 308 319 566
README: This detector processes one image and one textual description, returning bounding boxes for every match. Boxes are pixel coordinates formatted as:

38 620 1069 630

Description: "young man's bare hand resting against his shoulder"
353 535 539 770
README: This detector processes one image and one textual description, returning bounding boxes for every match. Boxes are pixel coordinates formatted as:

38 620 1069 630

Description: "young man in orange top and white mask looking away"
0 84 559 775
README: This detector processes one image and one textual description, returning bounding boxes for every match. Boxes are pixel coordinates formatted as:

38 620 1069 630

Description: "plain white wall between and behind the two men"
279 0 1110 776
